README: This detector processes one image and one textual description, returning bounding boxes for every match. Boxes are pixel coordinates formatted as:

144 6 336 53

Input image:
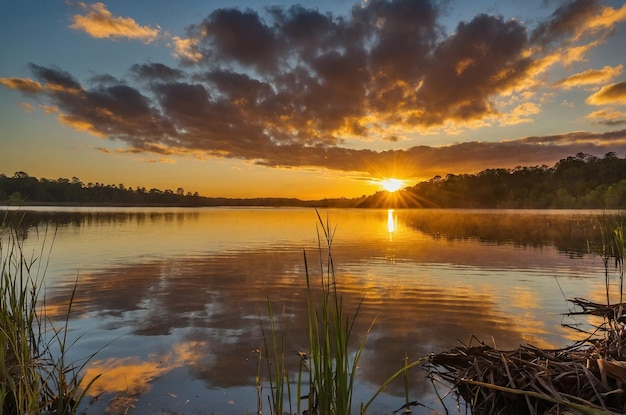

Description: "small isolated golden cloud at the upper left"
69 3 160 43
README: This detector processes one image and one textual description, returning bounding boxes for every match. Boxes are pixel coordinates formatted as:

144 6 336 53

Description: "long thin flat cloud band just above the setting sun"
247 130 626 177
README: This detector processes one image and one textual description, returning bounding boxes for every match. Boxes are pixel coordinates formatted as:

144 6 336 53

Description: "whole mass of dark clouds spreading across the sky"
2 0 625 182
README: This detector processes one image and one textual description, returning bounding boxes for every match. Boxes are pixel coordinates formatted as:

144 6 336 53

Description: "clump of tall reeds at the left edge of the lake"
0 215 95 415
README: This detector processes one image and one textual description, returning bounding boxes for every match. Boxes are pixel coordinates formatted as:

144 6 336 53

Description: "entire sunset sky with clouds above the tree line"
0 0 626 199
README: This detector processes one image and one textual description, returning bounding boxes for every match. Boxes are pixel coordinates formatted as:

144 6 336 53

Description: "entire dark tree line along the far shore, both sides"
0 152 626 209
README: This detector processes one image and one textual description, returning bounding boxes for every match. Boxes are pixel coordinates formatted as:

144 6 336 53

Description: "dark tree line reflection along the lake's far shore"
8 207 623 256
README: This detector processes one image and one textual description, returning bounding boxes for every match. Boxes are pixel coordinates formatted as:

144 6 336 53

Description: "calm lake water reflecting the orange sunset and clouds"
3 208 615 414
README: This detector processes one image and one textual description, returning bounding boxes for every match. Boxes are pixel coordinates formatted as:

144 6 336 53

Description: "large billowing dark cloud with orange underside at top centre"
179 0 529 135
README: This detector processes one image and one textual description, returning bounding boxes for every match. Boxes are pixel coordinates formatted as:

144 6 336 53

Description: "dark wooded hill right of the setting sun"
357 152 626 209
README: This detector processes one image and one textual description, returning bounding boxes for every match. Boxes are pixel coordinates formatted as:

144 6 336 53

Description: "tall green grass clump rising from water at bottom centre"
257 210 425 415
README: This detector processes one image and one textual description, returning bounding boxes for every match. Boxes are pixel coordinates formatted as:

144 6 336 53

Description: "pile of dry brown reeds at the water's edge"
430 298 626 415
